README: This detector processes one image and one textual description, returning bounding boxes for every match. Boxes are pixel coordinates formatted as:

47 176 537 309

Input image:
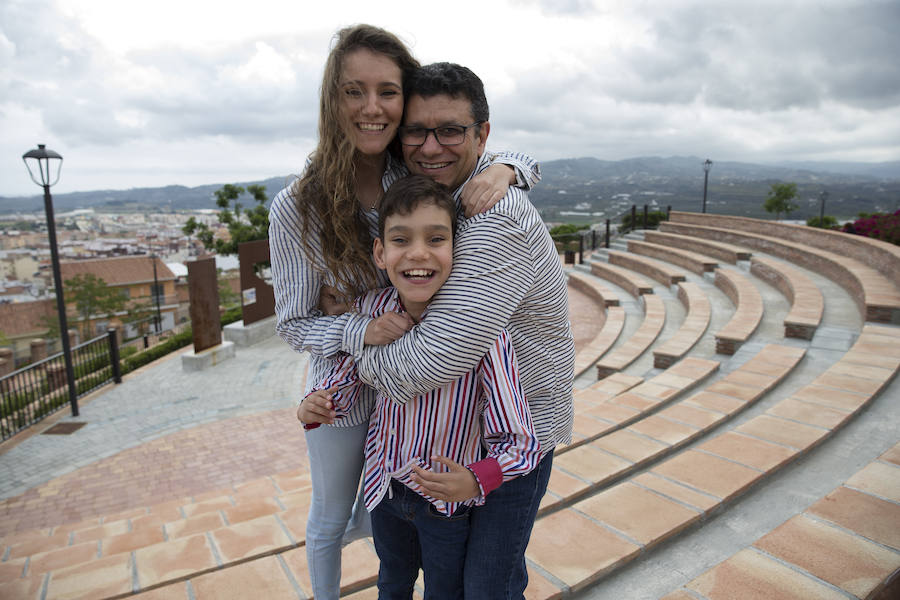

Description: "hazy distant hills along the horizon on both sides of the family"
0 156 900 221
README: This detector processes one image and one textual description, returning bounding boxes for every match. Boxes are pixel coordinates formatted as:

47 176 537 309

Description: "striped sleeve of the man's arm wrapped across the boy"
357 197 534 401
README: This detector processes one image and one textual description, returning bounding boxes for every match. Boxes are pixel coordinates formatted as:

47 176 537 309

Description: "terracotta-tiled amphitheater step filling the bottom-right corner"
661 444 900 600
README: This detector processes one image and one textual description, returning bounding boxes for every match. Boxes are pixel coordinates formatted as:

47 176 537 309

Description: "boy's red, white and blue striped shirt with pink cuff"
313 288 541 516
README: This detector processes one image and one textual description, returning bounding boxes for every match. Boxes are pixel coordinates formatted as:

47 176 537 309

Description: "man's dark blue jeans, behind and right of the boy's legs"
465 452 553 600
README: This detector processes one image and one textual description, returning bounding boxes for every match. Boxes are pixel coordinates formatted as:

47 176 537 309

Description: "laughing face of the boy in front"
373 200 453 319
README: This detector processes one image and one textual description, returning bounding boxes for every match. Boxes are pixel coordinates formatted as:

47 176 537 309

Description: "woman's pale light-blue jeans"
306 423 372 600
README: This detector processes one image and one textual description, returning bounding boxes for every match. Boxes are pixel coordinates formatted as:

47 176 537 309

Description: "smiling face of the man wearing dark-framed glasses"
402 94 490 190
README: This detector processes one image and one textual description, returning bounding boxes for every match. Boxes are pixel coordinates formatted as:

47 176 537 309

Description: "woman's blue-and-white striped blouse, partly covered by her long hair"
269 152 540 426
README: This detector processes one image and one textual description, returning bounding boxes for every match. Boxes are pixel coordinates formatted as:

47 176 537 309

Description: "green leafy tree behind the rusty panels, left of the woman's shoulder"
182 183 269 255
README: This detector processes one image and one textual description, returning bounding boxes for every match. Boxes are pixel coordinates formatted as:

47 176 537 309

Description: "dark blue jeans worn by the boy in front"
372 480 471 600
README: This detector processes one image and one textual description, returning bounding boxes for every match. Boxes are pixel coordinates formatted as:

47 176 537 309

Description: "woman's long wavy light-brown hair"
291 25 419 299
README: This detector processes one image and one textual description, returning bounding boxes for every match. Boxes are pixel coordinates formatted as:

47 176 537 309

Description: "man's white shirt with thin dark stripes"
354 152 575 453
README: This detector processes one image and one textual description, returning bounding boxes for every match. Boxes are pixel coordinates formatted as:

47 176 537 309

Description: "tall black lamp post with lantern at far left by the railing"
22 144 78 417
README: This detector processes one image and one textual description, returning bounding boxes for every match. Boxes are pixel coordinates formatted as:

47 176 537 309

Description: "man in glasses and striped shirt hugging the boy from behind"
355 63 575 600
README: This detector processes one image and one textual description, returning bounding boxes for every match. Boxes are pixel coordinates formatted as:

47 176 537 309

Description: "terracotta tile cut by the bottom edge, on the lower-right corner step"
684 549 846 600
